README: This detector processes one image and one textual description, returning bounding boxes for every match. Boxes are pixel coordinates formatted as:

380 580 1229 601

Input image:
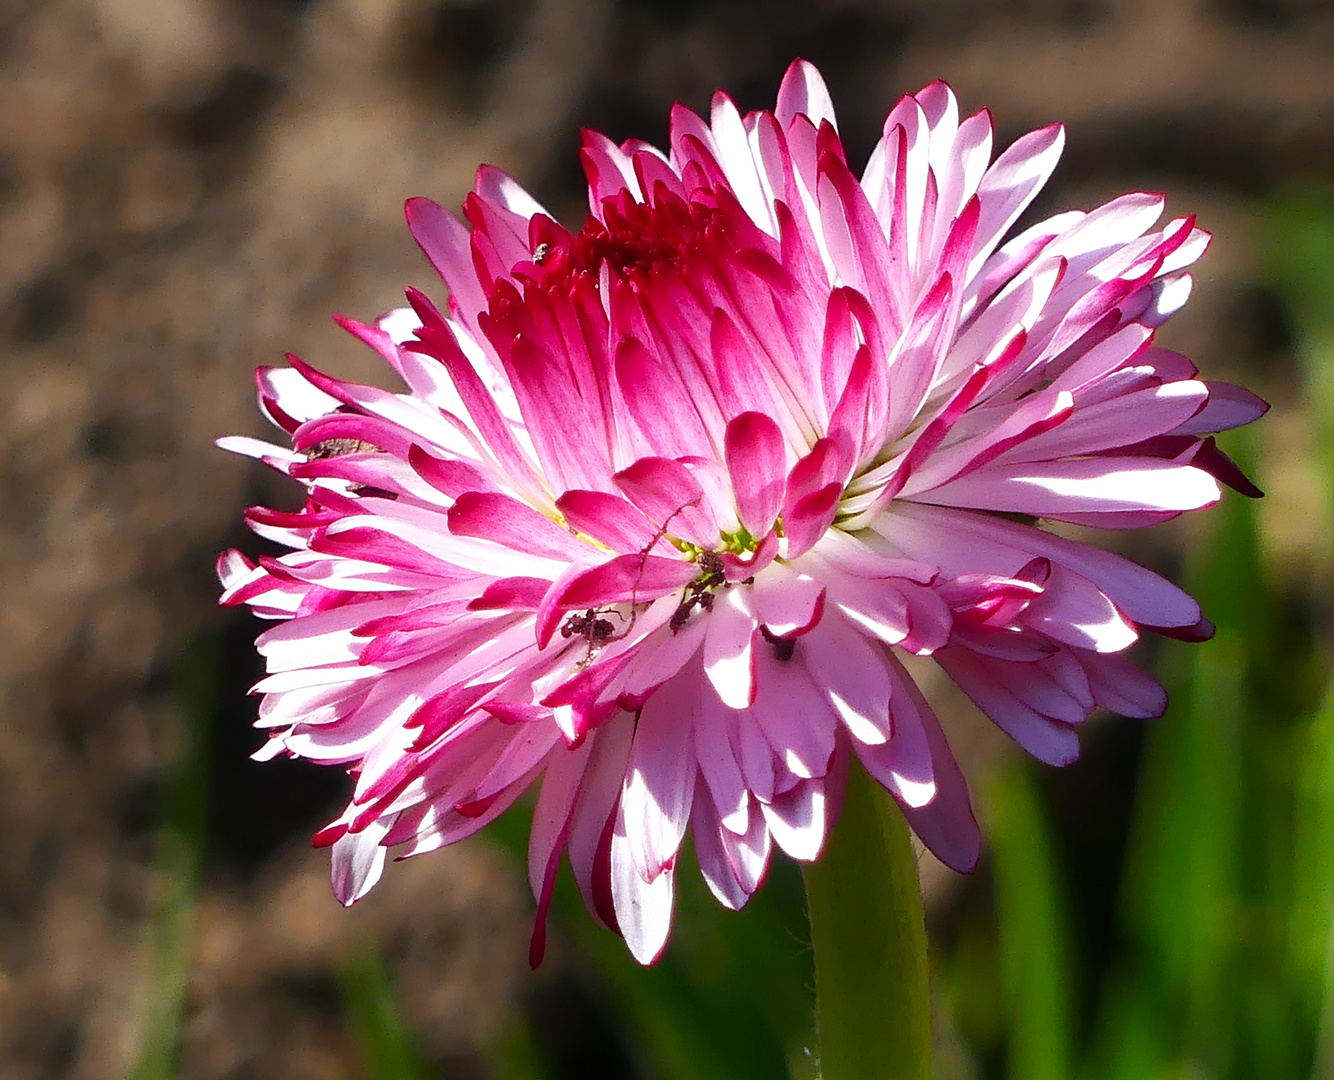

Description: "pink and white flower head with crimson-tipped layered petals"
219 63 1265 963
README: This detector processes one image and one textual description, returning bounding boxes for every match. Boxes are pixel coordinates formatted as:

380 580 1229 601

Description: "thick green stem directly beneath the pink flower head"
804 764 931 1080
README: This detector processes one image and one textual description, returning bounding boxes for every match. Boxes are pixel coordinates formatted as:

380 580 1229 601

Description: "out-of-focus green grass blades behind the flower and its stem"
135 193 1334 1080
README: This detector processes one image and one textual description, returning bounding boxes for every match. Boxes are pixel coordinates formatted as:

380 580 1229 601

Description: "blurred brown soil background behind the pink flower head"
0 0 1334 1080
